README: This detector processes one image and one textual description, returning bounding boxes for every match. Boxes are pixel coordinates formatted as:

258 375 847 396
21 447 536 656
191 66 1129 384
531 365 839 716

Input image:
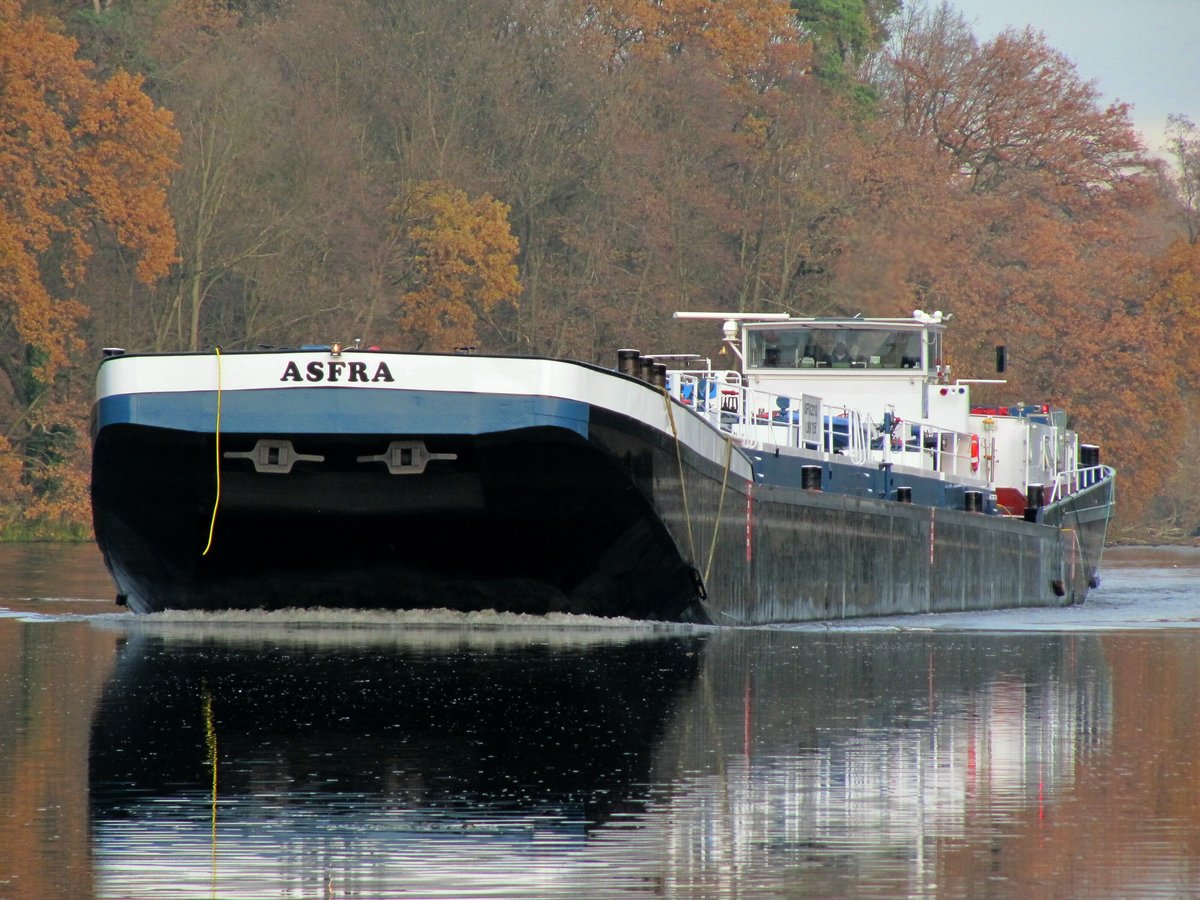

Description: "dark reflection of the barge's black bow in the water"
90 628 701 898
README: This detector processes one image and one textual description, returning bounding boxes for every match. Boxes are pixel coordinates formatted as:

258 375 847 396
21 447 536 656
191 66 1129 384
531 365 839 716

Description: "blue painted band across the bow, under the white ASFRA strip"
96 388 589 438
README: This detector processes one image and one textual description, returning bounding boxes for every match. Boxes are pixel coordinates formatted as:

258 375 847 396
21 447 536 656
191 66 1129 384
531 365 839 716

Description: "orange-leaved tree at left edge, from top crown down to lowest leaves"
0 0 179 532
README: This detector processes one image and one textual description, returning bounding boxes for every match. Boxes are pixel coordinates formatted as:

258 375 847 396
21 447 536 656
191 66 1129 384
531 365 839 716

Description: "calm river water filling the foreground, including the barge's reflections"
0 545 1200 898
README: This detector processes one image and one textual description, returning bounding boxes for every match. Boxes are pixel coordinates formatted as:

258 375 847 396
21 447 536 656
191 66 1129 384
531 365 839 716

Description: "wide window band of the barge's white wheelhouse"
745 325 926 370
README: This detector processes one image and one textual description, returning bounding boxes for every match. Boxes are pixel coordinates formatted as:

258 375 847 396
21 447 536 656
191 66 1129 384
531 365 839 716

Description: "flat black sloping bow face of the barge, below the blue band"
92 426 704 620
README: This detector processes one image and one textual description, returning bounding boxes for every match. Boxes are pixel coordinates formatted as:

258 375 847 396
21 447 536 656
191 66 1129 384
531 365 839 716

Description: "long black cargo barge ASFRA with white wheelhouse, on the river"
92 311 1115 625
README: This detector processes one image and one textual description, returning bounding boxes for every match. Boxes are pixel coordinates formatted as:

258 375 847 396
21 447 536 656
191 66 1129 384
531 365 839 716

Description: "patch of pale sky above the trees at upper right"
931 0 1200 156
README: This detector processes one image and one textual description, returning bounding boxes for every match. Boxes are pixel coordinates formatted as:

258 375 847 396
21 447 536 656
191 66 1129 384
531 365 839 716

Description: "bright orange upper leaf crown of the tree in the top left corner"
0 0 179 378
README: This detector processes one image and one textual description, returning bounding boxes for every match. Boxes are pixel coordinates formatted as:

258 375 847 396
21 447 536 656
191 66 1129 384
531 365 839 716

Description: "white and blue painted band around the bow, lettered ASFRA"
96 352 751 479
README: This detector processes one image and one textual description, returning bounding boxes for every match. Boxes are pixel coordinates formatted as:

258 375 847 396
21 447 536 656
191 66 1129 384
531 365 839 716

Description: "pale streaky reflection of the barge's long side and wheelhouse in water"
660 632 1111 895
